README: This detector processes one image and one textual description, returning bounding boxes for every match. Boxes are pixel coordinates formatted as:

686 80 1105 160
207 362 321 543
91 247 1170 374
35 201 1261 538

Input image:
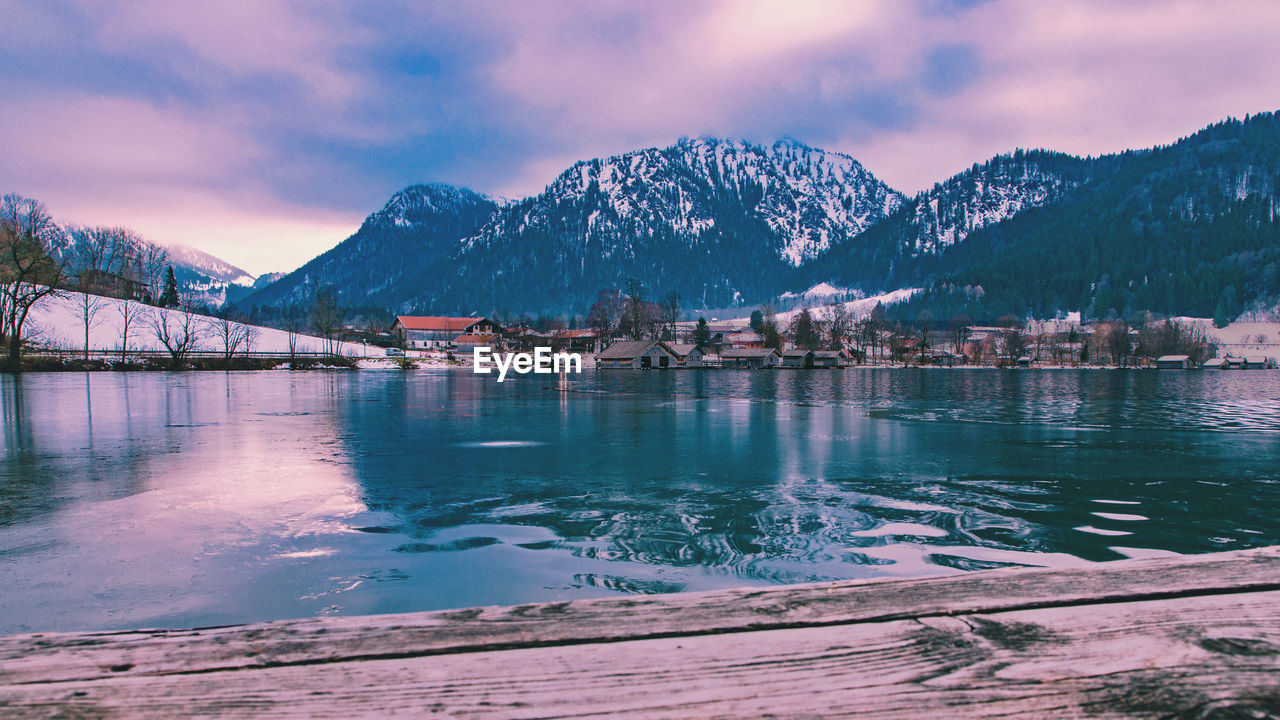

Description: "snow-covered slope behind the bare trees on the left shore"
23 292 373 357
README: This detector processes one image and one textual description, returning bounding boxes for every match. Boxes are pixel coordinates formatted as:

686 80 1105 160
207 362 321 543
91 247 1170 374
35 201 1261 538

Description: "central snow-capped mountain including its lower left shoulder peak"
241 138 902 313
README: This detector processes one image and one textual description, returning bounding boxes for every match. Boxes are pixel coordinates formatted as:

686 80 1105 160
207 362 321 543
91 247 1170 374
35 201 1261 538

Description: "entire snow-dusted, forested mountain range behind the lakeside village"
239 114 1280 316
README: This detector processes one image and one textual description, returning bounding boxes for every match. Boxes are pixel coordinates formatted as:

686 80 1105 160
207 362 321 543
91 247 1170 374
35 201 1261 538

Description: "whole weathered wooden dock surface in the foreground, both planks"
0 548 1280 717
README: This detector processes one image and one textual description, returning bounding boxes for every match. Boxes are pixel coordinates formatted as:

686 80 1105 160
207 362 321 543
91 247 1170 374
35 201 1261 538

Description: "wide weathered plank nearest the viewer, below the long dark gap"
0 591 1280 717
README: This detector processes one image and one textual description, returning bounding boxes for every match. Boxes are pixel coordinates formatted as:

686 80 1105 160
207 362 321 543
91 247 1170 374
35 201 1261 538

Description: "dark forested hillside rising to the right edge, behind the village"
870 113 1280 318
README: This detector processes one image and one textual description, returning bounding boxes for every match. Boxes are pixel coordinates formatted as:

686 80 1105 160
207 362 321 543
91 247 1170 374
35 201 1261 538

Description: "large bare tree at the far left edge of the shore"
0 193 68 370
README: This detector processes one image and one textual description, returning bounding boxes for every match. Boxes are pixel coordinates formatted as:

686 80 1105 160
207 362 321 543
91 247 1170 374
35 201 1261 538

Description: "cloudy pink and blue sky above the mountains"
0 0 1280 273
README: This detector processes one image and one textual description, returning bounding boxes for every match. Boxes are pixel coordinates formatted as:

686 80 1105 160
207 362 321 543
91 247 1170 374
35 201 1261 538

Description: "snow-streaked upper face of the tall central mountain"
476 138 902 268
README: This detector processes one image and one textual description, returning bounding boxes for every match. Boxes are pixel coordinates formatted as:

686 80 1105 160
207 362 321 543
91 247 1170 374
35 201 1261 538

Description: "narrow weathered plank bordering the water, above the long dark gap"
0 548 1280 684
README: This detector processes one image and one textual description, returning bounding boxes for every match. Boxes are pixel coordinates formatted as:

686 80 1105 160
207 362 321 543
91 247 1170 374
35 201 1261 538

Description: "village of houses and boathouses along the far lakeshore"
387 310 1280 370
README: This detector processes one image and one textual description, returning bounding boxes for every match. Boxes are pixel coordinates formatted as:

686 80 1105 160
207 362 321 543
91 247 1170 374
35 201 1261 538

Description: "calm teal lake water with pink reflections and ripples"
0 369 1280 633
